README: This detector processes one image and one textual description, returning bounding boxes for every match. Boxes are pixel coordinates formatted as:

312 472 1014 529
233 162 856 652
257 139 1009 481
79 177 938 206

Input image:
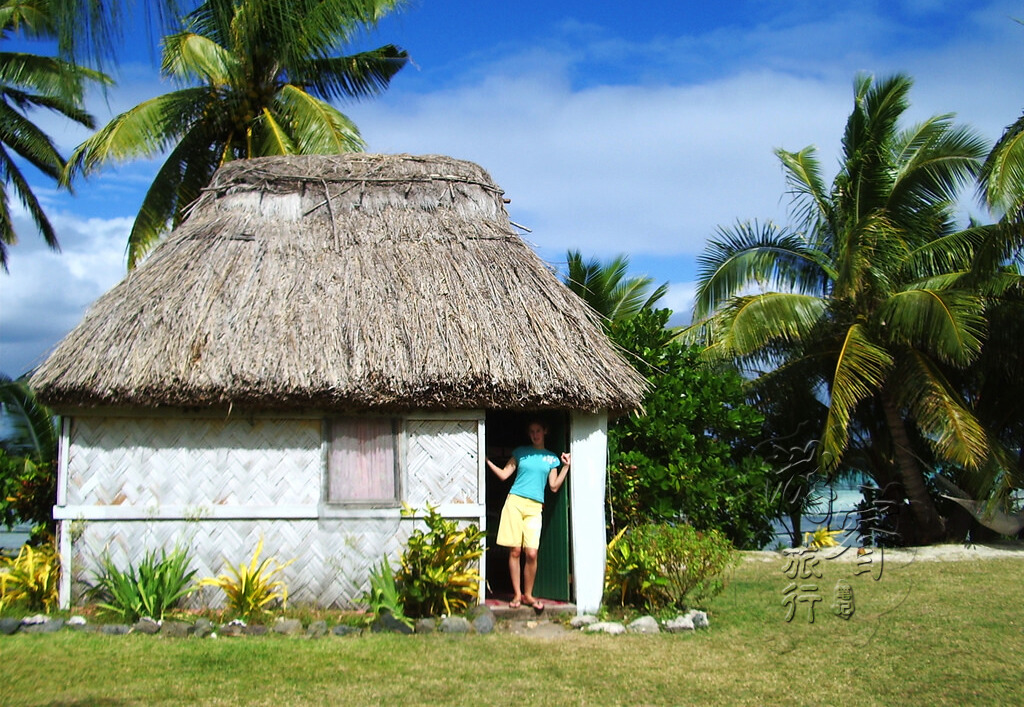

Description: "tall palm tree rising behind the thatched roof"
66 0 408 267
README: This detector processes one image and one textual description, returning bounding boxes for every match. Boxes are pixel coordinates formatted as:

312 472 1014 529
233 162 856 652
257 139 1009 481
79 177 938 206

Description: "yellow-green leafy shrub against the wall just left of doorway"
395 507 484 617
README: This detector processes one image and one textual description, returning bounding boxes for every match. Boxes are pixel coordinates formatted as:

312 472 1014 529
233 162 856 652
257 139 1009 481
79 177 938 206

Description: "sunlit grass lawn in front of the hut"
0 559 1024 705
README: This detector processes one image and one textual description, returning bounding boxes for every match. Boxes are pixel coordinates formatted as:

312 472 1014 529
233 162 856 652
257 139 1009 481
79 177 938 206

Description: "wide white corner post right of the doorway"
569 412 608 614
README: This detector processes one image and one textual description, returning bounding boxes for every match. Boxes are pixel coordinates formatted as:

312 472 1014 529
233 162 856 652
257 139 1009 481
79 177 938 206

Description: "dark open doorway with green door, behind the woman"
484 410 572 601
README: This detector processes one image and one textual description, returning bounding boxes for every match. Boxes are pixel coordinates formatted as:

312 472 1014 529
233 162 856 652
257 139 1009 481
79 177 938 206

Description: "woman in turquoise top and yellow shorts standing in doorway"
486 420 571 613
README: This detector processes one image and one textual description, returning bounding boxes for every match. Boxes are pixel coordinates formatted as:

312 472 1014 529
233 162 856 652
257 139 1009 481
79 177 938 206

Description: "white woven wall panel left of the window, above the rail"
68 417 322 507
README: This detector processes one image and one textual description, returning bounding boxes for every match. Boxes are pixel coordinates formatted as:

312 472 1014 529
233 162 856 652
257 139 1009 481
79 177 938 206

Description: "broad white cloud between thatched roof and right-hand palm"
352 66 849 255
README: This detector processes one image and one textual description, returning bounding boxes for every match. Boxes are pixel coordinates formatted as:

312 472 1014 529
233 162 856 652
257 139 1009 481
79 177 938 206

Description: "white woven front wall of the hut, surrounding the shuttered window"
65 417 482 608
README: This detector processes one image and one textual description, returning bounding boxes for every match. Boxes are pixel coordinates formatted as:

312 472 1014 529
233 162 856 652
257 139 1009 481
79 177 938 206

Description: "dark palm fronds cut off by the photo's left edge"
0 0 106 272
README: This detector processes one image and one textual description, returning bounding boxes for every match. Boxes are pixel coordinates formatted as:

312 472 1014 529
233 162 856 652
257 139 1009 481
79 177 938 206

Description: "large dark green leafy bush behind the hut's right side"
608 309 779 549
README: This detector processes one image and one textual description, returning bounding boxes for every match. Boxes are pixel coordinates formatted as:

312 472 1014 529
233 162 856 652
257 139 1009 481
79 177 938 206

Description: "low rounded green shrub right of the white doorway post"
605 524 739 611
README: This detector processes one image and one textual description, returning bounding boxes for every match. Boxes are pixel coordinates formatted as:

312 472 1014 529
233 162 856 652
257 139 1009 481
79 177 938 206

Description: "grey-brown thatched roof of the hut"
32 155 644 411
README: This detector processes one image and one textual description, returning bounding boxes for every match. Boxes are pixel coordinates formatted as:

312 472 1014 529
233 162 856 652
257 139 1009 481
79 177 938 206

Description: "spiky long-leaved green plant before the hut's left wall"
91 547 196 622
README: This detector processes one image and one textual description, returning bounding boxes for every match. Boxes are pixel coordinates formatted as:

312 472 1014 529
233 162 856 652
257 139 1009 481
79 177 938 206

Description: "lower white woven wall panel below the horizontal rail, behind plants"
72 518 417 609
